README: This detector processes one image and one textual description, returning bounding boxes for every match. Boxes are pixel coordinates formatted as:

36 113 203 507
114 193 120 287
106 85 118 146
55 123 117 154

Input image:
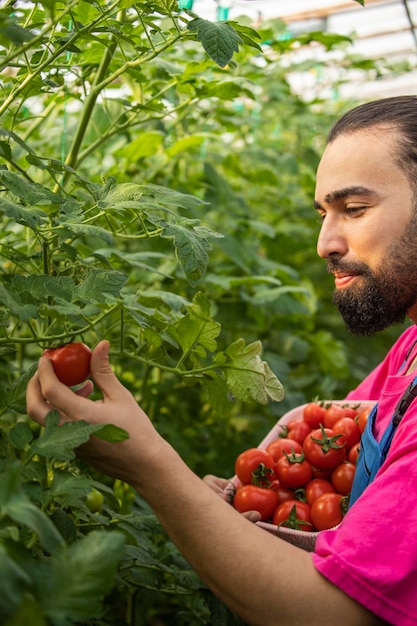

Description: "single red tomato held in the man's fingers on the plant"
42 342 91 387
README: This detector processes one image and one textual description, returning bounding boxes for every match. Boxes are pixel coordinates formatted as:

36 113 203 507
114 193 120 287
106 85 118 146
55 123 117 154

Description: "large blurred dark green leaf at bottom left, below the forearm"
38 531 125 624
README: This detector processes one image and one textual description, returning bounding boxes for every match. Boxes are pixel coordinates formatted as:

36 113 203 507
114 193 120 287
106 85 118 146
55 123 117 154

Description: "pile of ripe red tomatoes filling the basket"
233 402 371 531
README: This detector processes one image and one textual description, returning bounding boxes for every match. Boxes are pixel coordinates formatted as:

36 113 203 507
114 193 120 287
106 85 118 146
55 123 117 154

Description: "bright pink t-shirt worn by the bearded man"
312 326 417 626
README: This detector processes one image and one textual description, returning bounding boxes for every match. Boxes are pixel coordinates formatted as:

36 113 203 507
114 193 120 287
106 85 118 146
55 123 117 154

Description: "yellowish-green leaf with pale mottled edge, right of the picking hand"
216 339 284 404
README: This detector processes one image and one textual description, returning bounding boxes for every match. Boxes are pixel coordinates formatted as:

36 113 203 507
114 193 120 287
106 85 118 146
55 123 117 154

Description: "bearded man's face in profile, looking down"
315 128 417 335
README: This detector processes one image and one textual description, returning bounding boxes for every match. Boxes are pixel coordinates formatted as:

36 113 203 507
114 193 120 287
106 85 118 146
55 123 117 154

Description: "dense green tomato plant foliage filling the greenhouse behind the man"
0 0 410 626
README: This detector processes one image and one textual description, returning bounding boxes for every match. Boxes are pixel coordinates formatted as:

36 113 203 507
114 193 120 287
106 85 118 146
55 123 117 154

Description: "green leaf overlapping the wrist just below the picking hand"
31 411 128 461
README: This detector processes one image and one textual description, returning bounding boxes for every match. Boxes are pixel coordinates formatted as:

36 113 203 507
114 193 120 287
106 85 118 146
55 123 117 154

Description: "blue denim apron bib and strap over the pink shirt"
349 376 417 508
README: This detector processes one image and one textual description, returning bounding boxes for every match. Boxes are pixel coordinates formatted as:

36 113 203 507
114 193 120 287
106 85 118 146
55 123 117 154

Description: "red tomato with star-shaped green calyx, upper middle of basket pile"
303 426 346 469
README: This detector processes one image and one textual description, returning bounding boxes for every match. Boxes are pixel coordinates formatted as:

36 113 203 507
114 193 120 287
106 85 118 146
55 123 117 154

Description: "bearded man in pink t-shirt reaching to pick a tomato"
27 96 417 626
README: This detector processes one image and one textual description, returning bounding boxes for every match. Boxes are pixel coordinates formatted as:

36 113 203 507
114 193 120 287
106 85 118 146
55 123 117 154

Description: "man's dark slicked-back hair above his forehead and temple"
327 96 417 187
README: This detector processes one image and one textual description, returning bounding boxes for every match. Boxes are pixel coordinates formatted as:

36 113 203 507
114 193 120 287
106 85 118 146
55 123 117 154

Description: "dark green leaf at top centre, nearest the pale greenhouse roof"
187 17 243 67
